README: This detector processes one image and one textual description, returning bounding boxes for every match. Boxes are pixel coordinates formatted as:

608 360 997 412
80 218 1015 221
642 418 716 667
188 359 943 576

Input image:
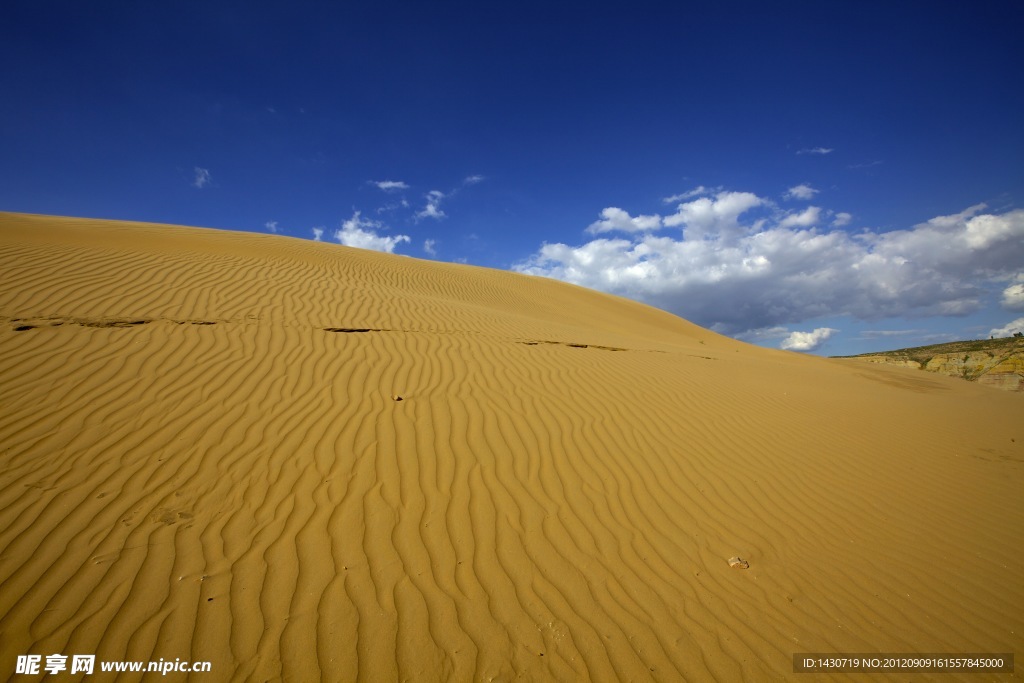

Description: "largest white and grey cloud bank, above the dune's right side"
514 191 1024 334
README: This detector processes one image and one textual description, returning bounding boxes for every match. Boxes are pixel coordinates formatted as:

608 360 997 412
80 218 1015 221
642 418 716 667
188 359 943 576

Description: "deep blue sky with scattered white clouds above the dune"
0 0 1024 355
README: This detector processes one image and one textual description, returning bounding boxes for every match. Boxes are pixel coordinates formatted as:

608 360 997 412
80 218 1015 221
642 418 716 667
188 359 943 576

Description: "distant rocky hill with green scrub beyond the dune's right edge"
833 337 1024 391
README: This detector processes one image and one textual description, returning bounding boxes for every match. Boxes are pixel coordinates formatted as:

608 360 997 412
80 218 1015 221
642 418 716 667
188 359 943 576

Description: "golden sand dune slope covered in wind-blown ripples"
0 214 1024 681
